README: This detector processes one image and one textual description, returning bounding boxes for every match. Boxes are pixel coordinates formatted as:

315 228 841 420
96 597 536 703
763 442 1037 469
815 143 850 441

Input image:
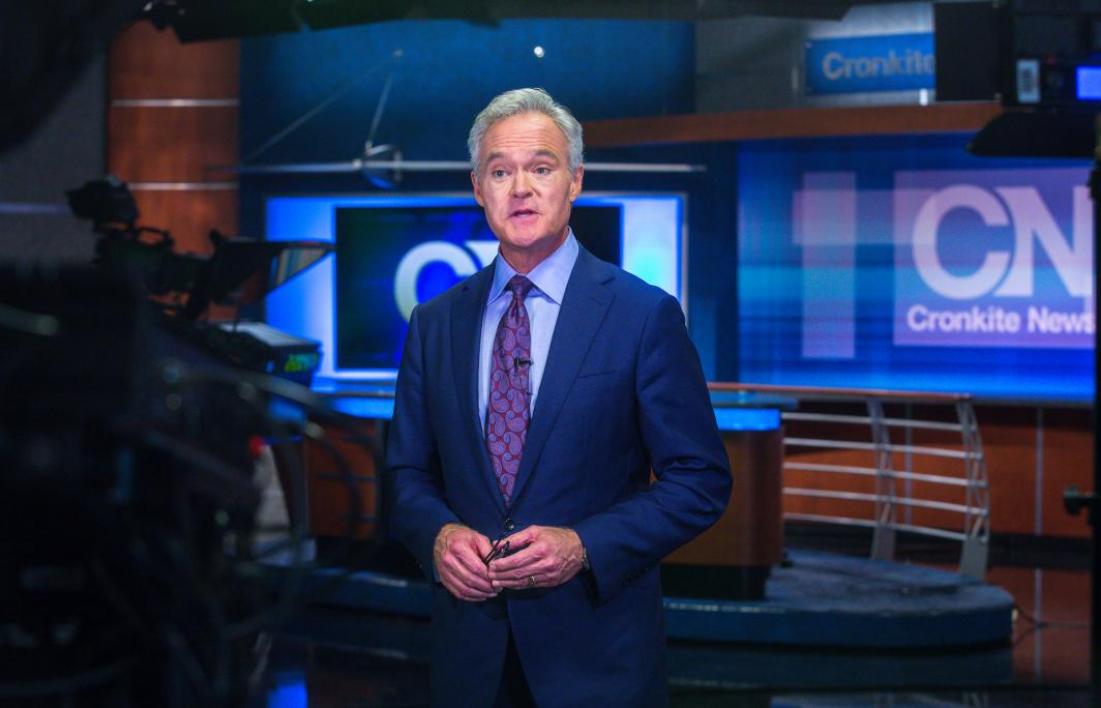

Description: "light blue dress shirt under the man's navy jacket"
478 229 578 428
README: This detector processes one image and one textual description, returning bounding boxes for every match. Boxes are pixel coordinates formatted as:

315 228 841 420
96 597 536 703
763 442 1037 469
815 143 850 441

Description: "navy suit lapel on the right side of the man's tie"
510 248 614 505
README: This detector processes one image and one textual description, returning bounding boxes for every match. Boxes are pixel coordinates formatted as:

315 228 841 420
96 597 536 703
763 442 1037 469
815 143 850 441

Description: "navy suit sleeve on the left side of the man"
386 308 459 580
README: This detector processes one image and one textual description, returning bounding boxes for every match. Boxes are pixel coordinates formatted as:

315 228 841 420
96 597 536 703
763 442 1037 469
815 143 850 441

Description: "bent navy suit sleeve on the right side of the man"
575 297 732 600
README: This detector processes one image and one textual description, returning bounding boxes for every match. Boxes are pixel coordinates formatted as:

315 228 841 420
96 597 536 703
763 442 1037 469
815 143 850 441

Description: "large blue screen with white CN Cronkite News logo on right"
739 137 1094 401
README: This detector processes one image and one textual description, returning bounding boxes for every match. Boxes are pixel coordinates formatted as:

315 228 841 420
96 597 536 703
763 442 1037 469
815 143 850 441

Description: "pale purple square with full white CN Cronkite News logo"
894 168 1095 349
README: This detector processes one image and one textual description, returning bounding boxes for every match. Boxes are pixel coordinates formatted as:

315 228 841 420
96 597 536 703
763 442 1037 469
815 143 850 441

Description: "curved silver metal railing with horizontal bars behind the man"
712 384 990 579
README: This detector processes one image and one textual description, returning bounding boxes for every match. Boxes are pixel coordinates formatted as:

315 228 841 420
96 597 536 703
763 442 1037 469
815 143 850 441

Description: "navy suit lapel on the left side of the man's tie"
451 265 505 513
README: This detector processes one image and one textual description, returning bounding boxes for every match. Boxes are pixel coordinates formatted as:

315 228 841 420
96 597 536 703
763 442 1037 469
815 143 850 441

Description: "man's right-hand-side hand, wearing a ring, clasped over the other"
489 526 585 590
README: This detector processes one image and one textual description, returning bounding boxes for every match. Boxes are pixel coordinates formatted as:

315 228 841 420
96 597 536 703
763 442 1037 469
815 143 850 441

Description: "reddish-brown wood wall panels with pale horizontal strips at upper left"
107 22 240 262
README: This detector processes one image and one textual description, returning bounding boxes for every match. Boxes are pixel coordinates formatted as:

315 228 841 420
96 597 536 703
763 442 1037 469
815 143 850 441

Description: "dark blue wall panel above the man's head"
241 19 696 166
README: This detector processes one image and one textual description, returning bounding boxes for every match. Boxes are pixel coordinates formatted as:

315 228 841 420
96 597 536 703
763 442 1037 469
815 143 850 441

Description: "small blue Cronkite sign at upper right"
804 32 936 94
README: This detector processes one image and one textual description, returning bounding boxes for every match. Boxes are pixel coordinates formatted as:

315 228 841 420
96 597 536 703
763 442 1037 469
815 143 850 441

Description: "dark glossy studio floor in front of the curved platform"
255 539 1092 708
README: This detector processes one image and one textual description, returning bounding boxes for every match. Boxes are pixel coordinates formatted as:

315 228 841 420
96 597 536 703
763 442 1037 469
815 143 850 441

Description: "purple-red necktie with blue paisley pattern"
486 275 532 504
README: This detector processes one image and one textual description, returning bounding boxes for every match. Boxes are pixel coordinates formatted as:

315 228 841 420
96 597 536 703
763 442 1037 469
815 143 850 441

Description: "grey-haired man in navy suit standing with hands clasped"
386 89 731 706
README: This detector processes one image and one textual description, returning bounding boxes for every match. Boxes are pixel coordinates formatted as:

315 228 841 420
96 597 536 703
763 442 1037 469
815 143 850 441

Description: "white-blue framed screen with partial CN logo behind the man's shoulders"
265 194 685 378
